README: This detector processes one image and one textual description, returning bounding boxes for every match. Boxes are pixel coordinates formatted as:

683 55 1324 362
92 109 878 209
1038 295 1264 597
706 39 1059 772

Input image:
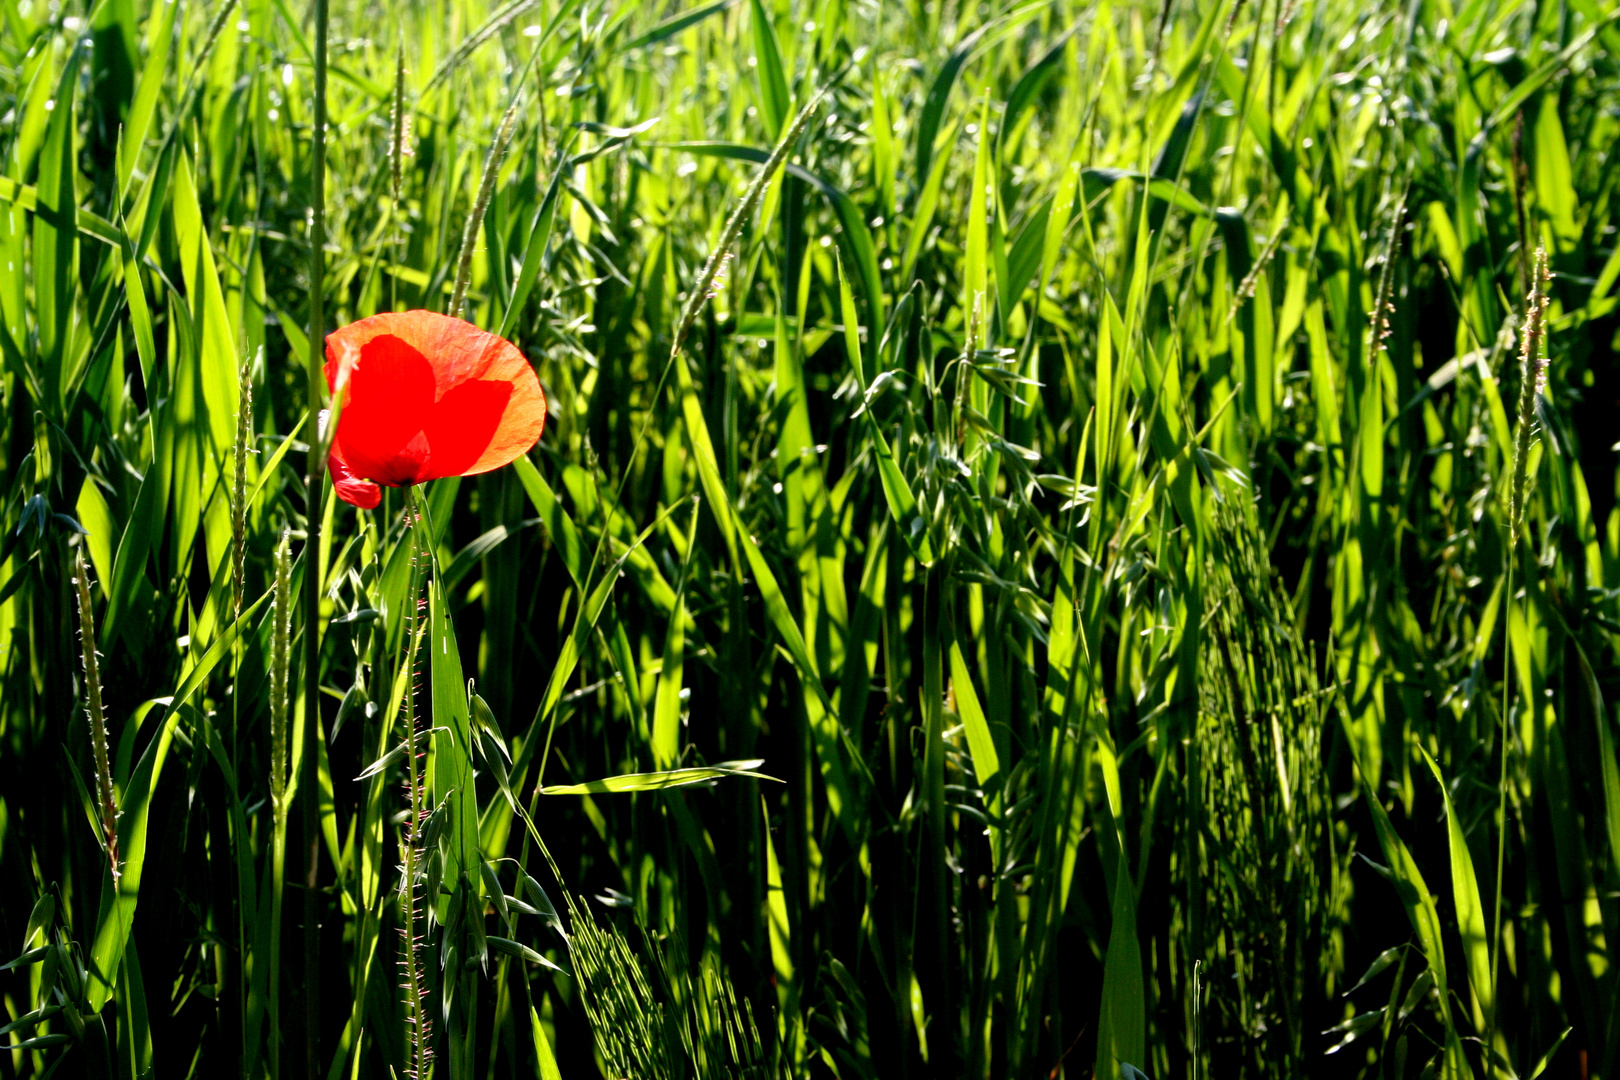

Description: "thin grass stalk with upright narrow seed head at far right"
1486 248 1549 1075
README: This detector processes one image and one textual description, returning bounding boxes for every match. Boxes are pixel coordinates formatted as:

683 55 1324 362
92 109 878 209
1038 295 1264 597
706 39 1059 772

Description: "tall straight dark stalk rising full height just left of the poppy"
301 0 327 1080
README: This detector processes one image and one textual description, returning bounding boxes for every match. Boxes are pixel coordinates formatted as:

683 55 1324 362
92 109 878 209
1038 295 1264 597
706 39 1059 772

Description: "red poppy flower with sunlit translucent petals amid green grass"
326 311 546 510
